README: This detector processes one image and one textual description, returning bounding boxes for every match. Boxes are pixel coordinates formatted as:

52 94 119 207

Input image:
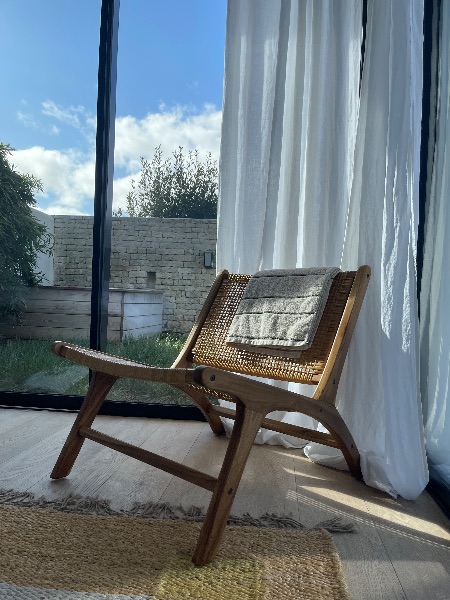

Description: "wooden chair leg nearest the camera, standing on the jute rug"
192 404 264 567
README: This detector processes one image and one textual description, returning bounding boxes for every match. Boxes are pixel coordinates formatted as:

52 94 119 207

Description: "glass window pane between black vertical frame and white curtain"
104 0 226 403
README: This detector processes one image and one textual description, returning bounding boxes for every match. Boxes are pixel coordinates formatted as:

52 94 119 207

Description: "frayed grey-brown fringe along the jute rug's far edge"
0 490 355 533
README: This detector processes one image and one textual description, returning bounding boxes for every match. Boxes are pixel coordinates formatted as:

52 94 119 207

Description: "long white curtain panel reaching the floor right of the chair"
307 0 428 499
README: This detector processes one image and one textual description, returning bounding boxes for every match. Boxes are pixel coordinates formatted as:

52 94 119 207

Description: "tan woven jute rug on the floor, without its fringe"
0 495 350 600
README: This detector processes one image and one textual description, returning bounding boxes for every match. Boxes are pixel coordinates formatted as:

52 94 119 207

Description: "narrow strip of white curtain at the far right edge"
420 2 450 492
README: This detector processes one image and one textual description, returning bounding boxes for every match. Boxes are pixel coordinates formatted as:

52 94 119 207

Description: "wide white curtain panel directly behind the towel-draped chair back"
217 0 361 446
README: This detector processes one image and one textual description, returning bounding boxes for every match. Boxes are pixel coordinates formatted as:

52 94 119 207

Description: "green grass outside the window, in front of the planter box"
0 334 190 404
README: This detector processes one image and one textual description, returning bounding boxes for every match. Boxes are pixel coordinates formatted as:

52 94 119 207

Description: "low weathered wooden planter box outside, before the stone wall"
1 286 163 341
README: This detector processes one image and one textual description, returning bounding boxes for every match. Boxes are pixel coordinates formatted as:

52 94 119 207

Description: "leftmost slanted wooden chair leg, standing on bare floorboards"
50 372 117 479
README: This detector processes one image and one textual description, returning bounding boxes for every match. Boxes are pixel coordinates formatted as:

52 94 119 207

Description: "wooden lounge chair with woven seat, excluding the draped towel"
51 266 370 566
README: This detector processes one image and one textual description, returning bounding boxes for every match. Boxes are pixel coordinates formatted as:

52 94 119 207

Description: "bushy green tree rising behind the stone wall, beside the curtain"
125 146 219 219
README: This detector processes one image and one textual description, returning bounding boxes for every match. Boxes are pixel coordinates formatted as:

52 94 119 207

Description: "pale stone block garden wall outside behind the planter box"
53 216 217 333
